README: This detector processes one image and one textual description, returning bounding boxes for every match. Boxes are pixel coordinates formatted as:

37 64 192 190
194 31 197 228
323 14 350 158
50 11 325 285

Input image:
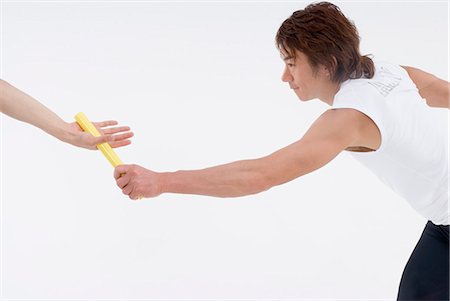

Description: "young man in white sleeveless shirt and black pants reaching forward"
114 2 449 300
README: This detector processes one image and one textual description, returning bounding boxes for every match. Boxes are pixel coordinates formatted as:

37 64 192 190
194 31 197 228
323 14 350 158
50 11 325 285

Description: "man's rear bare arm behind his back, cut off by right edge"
402 66 450 109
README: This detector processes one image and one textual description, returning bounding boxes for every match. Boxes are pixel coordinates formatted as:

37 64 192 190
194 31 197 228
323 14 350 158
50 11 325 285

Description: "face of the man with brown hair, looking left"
281 51 326 101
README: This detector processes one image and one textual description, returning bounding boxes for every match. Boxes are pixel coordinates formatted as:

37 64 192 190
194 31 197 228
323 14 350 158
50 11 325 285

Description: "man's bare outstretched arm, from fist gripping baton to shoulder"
119 109 367 199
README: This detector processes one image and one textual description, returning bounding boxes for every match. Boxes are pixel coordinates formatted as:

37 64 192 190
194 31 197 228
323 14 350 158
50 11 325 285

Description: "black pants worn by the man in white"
397 221 449 300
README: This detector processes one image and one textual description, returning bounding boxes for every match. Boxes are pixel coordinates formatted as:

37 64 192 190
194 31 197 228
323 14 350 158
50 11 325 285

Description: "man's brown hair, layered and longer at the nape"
275 2 375 83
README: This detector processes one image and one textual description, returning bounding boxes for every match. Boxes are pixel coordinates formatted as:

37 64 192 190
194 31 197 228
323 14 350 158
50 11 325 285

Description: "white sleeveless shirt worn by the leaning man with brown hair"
332 62 449 225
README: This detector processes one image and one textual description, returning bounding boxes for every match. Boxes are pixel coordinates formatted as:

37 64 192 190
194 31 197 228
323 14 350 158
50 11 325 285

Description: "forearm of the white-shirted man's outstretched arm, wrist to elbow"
160 159 271 198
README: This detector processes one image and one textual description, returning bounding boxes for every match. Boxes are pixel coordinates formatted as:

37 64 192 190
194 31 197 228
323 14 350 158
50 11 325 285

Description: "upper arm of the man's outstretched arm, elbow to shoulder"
261 109 360 186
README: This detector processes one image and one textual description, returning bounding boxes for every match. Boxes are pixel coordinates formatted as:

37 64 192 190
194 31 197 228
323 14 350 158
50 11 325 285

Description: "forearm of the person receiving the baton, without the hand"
0 80 73 142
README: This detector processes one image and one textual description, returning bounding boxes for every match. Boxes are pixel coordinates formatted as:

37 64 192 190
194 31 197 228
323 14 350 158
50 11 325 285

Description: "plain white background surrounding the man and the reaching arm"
1 1 449 300
